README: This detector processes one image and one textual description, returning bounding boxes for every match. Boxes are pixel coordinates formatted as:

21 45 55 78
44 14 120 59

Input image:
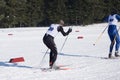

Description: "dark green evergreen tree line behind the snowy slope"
0 0 120 28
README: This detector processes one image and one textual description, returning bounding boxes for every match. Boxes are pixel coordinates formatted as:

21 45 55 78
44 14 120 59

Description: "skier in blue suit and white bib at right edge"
105 9 120 58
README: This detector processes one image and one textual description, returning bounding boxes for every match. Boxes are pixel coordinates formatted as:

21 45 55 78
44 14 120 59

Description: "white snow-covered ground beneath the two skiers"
0 23 120 80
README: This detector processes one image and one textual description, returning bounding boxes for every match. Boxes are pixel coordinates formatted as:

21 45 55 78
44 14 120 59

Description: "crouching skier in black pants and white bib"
43 20 72 69
